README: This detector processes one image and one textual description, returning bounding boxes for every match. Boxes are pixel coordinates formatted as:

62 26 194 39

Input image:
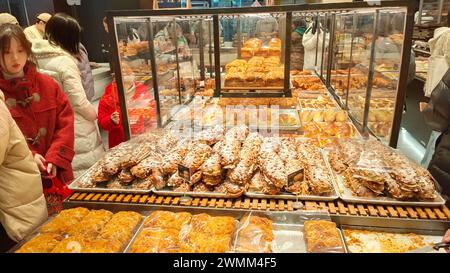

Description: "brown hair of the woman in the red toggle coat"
0 24 34 72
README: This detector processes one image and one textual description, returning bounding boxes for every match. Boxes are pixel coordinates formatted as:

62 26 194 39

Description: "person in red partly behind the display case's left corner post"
98 77 156 149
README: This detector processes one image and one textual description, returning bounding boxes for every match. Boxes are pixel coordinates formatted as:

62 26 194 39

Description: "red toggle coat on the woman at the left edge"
0 63 74 183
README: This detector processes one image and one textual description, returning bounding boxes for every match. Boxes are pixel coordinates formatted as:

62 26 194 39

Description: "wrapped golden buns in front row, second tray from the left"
128 211 237 253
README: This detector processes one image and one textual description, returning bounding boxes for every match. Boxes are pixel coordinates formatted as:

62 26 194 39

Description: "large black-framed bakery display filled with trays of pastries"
41 1 450 253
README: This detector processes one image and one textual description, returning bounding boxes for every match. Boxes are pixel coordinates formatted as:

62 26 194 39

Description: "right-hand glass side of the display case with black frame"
317 7 412 147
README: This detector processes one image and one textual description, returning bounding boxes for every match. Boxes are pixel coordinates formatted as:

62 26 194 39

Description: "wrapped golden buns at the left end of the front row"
11 208 142 253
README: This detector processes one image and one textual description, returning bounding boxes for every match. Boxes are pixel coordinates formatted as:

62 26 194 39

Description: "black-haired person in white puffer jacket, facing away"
31 13 104 178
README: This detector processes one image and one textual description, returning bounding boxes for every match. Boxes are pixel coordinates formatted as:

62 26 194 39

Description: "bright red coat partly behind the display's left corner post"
98 82 156 149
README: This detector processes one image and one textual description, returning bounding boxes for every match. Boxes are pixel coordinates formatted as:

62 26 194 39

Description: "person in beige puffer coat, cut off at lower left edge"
0 91 47 252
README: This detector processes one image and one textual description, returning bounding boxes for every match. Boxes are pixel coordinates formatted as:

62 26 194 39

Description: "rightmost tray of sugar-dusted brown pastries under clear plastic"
328 137 444 205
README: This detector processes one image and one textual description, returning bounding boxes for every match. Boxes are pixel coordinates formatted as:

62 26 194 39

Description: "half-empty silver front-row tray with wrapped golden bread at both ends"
234 211 345 253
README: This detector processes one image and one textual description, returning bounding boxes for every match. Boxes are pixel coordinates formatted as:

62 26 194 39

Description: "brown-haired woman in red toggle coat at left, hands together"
0 24 74 184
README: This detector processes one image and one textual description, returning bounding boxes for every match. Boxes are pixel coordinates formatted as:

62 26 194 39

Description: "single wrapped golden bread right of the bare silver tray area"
304 220 345 253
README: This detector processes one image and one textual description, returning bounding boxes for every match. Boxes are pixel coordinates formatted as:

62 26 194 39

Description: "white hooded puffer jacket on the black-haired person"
32 40 104 177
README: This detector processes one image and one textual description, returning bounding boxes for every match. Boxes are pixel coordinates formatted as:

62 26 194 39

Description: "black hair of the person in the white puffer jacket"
45 13 81 55
